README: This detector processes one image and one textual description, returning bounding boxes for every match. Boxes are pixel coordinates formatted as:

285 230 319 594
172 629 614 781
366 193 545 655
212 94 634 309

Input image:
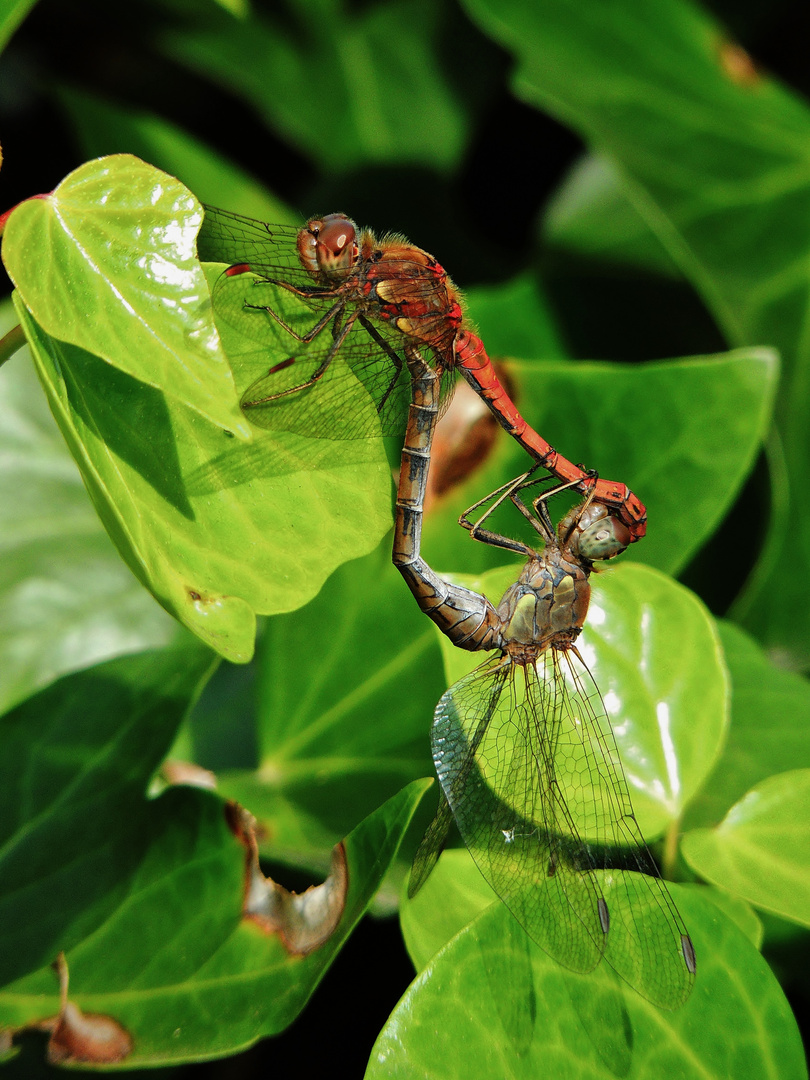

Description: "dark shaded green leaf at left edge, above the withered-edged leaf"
0 642 219 985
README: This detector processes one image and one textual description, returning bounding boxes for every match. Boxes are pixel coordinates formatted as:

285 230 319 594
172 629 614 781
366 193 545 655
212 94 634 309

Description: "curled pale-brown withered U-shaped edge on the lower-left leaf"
226 802 349 956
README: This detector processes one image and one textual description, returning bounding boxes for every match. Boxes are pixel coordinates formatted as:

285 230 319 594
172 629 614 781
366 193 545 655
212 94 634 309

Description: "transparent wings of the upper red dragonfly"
198 208 454 440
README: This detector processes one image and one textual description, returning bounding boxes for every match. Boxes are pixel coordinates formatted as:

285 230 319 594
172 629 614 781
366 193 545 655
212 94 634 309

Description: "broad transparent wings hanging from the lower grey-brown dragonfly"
433 649 694 1009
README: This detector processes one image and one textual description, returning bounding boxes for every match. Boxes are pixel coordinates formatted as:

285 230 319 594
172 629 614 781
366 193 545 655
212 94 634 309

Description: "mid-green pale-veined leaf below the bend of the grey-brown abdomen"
212 537 444 866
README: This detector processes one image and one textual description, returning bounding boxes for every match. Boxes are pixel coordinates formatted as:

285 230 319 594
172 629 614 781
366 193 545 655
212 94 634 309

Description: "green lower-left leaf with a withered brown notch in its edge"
0 782 432 1068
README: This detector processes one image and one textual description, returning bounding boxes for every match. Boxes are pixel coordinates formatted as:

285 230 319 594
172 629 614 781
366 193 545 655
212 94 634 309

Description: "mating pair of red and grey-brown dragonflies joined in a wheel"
199 208 696 1009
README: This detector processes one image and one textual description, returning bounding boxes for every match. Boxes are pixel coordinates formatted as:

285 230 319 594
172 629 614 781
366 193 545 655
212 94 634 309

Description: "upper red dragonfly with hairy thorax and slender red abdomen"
198 206 647 542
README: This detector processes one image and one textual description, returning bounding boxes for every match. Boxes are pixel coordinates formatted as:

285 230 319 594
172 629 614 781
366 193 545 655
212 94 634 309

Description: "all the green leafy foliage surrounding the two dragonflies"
0 0 810 1078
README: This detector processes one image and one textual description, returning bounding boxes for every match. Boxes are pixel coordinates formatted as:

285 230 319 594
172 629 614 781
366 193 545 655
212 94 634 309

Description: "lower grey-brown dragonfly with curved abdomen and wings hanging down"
394 350 697 1009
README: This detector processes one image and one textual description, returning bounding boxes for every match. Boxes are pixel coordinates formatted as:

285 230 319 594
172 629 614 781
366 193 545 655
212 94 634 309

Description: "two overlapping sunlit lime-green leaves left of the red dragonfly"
5 156 390 661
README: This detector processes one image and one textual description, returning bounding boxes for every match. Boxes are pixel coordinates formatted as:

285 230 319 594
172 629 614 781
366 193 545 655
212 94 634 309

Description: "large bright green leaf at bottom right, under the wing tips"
380 887 806 1080
